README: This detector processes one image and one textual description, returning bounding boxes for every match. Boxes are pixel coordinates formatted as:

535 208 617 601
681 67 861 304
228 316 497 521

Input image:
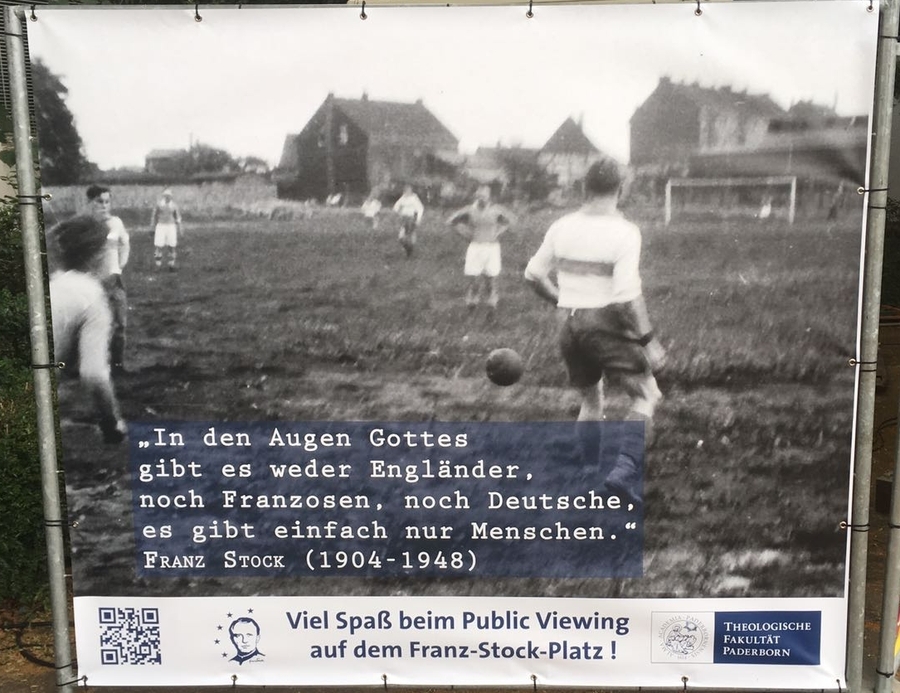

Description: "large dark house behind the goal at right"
630 77 867 219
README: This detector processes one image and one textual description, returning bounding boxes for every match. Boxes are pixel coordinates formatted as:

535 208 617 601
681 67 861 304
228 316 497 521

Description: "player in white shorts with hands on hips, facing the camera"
447 185 515 308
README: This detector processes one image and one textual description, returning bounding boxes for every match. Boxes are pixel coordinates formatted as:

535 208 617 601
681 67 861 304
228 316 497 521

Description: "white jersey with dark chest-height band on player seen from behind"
525 210 641 308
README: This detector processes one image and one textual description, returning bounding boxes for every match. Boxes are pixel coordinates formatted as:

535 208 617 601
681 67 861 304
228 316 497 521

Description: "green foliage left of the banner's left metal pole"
0 204 47 602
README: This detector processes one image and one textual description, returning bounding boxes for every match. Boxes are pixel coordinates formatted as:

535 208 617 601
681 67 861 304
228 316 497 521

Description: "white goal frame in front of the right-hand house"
666 176 797 226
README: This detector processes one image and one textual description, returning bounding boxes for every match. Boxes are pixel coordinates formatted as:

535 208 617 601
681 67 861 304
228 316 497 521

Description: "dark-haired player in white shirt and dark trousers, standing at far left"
87 185 131 375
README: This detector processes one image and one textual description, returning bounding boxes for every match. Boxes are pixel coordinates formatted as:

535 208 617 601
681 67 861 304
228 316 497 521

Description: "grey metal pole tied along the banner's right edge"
847 0 898 691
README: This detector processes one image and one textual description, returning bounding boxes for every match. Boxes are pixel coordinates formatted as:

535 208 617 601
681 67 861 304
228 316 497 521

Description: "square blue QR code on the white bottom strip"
100 607 162 665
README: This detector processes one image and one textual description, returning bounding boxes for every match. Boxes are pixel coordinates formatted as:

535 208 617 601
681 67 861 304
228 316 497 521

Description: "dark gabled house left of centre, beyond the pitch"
275 94 459 200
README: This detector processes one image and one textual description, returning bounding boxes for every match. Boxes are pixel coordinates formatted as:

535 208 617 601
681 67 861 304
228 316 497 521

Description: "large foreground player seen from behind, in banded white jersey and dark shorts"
525 159 666 501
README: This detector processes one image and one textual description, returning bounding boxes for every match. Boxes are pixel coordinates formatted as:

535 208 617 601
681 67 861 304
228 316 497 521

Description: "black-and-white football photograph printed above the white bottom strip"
27 2 877 604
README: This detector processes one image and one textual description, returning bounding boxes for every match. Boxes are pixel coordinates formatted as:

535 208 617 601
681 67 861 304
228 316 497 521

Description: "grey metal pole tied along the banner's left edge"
3 7 76 693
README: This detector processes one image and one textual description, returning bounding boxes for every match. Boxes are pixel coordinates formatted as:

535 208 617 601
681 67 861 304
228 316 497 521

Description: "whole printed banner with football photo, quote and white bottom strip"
28 2 877 689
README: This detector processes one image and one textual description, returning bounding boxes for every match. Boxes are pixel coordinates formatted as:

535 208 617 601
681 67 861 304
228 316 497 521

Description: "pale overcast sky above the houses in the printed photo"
27 0 878 168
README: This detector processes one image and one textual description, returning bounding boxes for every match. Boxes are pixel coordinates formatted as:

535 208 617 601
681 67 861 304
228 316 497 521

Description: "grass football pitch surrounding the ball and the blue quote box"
61 205 859 597
